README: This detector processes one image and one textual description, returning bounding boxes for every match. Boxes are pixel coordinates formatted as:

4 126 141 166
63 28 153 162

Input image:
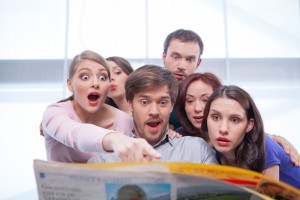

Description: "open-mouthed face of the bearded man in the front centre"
129 86 173 145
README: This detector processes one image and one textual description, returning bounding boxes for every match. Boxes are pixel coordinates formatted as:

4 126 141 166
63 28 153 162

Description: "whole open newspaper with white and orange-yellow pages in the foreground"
34 160 300 200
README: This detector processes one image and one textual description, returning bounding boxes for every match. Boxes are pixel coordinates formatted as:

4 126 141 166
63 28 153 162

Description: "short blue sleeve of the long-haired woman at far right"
265 136 280 169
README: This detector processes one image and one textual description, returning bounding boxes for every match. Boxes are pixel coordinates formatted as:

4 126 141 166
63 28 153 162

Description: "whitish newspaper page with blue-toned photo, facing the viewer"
34 160 272 200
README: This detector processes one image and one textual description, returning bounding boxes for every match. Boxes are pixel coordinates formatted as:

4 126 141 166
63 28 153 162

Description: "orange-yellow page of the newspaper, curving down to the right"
72 162 300 200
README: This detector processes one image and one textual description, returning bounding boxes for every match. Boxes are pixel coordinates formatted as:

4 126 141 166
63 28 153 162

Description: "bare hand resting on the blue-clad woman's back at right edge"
268 134 300 167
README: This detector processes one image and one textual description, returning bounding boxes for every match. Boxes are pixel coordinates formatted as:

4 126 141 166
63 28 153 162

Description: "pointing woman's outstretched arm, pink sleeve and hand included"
42 104 160 161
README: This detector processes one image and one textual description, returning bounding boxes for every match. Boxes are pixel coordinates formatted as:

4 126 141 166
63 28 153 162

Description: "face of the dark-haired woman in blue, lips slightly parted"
207 97 254 158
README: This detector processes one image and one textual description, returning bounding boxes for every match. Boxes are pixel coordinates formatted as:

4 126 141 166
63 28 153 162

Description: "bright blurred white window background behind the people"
0 0 300 200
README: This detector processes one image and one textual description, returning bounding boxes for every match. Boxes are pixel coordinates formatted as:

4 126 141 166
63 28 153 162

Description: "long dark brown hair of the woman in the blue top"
201 85 265 172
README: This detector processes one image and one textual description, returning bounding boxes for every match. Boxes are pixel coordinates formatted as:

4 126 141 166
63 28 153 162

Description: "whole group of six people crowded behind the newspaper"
41 29 300 189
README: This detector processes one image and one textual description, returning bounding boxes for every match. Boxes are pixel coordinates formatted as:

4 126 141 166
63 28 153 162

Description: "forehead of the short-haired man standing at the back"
167 39 200 57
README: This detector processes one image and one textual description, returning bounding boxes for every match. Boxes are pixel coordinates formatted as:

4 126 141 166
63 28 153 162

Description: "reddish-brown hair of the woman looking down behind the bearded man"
174 72 222 140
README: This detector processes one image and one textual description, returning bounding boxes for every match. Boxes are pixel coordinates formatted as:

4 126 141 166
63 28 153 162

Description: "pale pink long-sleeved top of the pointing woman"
42 101 133 163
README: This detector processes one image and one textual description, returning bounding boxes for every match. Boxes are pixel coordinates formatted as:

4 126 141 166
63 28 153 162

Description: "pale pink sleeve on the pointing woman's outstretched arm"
42 103 112 152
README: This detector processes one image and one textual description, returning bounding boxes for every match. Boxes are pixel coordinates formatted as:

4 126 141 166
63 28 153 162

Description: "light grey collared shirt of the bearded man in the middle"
88 134 218 164
